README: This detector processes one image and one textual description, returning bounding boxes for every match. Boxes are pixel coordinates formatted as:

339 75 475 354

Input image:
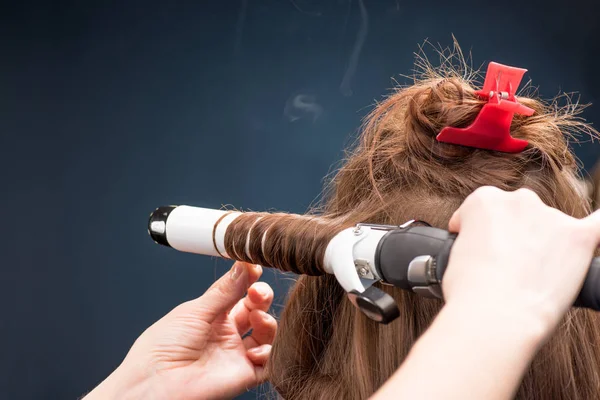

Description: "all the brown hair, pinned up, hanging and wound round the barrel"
225 45 600 400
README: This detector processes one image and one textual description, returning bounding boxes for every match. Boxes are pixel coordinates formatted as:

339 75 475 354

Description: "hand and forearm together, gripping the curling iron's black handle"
374 187 600 399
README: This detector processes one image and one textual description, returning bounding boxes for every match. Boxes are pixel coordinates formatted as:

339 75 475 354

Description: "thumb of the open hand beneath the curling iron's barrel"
191 262 250 323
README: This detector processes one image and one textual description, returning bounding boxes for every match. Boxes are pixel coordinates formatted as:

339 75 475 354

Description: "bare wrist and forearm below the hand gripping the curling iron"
375 297 546 399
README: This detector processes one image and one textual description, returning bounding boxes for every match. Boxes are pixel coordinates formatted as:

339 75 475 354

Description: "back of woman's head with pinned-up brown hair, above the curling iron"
325 54 594 227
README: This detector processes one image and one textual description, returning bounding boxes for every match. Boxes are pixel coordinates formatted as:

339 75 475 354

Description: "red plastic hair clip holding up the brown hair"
437 62 534 153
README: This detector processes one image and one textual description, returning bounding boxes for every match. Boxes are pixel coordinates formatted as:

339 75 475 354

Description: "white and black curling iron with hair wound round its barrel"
148 206 600 324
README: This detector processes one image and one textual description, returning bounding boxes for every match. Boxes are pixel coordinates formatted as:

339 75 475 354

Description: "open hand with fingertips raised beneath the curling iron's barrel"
85 263 277 400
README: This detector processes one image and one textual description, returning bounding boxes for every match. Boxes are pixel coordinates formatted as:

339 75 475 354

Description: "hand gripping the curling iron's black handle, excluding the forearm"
442 187 600 337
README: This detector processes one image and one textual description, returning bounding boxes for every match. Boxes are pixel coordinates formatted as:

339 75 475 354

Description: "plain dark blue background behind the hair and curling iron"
0 0 600 399
